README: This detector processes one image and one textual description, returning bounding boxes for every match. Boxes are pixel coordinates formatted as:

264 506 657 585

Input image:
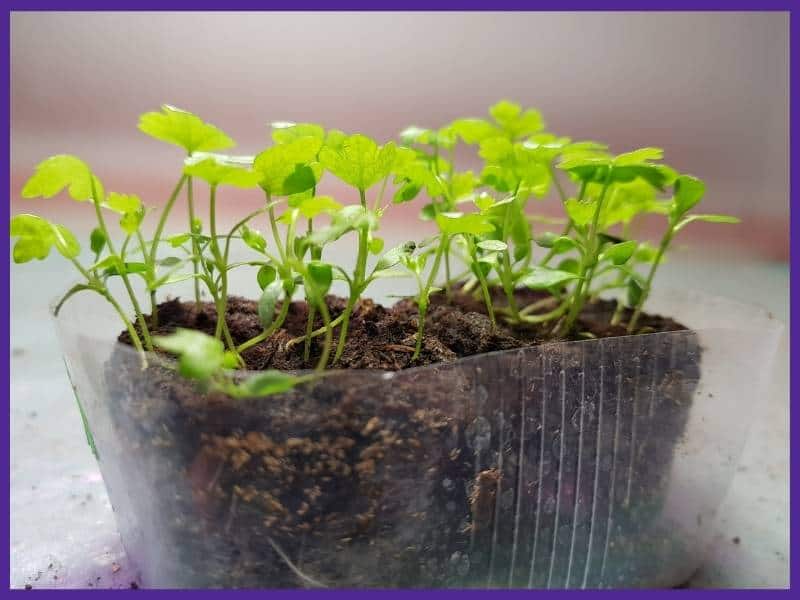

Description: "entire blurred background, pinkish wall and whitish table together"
10 12 789 587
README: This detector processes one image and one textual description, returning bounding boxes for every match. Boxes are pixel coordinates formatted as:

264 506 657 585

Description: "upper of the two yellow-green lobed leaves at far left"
22 154 103 202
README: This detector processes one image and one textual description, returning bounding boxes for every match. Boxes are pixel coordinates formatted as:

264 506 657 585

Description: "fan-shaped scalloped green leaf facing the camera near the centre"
319 134 396 191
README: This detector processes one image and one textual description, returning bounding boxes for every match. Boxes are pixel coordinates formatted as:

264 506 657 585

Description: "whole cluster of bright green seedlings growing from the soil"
11 101 738 397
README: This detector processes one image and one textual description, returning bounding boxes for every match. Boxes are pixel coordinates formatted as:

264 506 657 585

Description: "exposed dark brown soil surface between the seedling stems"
126 290 685 371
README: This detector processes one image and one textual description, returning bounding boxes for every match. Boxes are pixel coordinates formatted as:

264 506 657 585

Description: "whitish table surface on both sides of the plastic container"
10 240 789 588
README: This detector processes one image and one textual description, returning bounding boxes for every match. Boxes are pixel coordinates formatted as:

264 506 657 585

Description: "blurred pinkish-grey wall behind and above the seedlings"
11 13 788 259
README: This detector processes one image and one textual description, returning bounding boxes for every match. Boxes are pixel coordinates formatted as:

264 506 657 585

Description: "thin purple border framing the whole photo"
0 0 800 600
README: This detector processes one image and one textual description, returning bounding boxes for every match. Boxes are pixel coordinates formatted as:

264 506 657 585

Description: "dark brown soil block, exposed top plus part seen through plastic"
109 292 700 588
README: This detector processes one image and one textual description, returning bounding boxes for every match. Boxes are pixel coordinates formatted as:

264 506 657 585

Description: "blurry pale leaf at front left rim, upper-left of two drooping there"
153 328 225 382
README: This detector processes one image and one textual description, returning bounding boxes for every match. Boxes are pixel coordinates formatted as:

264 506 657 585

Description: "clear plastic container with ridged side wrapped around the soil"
57 293 782 588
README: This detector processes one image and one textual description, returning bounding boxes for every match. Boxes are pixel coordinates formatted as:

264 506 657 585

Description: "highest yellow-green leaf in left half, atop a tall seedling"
139 104 235 154
